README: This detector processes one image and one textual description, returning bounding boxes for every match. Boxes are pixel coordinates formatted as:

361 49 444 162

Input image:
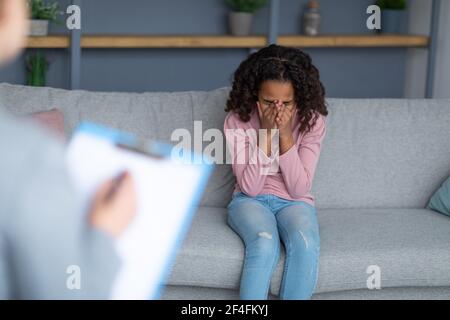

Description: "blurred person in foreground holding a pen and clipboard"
0 0 136 299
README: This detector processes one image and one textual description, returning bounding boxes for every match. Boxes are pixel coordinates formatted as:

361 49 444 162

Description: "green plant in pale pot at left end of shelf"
28 0 60 36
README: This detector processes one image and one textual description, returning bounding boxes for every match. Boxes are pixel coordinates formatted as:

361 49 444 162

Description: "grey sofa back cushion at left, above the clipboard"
0 84 197 141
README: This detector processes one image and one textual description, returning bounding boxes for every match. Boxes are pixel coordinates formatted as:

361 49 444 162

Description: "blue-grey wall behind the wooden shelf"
0 0 414 97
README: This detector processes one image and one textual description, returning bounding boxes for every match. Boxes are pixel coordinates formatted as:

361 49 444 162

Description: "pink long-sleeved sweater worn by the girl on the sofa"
224 110 326 205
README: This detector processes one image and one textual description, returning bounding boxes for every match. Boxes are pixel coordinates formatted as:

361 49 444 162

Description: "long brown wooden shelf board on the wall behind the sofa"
27 35 429 49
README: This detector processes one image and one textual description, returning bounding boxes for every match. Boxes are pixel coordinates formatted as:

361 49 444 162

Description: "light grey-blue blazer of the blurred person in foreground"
0 111 119 299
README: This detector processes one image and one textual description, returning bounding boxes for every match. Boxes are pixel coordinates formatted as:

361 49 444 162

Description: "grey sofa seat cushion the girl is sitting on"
168 207 450 294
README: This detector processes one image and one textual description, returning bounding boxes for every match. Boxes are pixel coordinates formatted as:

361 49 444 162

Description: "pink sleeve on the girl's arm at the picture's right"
280 117 326 199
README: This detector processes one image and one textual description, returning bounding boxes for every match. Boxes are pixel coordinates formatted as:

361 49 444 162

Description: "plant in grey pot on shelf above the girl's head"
226 0 267 36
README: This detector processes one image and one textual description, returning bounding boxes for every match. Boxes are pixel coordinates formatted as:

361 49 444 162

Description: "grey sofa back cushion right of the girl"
313 99 450 209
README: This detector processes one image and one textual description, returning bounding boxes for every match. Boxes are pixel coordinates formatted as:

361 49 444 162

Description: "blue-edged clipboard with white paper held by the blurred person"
66 123 213 300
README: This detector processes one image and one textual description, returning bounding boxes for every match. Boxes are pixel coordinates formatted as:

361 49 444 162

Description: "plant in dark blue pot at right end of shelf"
376 0 407 33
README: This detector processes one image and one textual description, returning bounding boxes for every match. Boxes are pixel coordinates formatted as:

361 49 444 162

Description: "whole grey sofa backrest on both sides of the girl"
0 84 450 208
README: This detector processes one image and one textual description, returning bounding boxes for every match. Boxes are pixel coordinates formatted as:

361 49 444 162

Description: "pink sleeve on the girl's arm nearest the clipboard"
224 114 274 197
